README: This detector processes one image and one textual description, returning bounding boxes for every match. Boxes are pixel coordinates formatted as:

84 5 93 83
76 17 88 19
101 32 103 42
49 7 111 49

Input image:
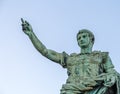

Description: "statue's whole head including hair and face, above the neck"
77 29 95 48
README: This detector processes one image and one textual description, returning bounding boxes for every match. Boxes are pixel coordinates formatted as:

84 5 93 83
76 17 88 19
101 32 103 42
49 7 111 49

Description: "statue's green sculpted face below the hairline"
77 33 91 48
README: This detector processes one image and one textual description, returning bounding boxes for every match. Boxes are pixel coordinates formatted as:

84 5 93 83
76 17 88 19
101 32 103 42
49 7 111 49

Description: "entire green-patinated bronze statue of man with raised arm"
21 19 120 94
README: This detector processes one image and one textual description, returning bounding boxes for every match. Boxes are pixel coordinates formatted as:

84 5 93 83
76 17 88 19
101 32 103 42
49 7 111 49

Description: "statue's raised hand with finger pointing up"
21 18 33 35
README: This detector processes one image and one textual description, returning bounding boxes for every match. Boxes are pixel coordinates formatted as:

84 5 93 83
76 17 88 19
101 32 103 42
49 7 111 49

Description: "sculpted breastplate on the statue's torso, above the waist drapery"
67 53 102 83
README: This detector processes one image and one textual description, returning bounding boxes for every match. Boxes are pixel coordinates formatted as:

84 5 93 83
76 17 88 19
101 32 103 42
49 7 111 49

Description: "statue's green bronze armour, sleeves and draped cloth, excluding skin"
60 51 120 94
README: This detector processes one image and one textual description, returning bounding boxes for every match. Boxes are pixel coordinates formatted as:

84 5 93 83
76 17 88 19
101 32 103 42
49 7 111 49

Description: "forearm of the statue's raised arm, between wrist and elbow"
28 32 47 56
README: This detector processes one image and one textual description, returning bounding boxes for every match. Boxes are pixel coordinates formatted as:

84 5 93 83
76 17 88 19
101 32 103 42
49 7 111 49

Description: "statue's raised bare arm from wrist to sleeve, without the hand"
29 32 62 63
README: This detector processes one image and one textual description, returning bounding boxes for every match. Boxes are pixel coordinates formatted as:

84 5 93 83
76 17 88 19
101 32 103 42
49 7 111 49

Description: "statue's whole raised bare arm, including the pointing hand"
21 18 63 63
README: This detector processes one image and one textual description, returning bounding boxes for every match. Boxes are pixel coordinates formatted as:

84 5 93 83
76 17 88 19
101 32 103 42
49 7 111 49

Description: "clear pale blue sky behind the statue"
0 0 120 94
